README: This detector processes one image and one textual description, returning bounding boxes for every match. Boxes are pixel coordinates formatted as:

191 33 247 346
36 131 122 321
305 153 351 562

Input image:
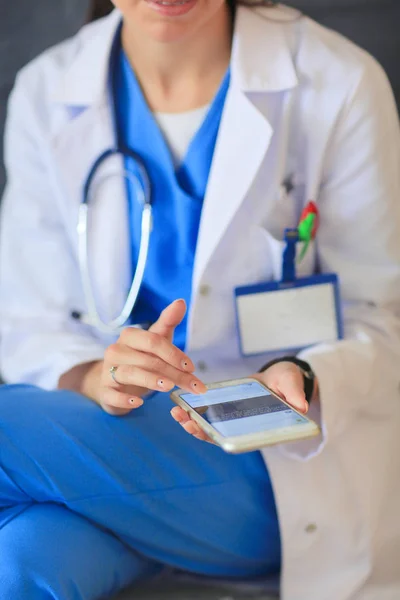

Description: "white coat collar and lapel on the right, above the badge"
193 6 298 292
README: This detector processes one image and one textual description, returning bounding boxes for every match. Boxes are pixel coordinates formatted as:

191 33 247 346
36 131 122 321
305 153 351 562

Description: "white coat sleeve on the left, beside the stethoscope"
0 75 104 389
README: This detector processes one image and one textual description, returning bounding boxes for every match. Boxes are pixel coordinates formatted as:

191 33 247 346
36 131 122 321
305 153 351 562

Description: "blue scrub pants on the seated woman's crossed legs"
0 386 280 600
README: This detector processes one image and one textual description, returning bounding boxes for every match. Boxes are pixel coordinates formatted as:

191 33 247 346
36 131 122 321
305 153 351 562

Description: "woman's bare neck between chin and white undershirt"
122 4 232 112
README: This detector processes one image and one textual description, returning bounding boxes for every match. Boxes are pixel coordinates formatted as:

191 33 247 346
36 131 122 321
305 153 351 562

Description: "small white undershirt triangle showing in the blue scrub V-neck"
154 104 209 165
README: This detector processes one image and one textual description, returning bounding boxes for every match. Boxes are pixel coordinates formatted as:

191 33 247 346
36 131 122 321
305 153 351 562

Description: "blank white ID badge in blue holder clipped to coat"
235 275 343 356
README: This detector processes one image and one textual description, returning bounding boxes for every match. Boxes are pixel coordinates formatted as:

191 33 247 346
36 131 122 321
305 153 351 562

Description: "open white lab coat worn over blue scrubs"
0 8 400 600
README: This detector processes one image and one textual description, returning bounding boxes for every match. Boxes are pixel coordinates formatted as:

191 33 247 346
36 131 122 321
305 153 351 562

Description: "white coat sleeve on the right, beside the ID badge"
282 58 400 459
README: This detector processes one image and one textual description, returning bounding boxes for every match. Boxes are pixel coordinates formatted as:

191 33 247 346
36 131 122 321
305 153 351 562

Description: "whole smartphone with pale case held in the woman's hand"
171 378 320 454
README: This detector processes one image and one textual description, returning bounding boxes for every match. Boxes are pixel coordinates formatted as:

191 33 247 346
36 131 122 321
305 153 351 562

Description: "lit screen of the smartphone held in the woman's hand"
181 381 308 437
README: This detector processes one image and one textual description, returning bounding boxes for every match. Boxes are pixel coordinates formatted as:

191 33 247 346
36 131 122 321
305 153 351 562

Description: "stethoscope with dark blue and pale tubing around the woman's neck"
71 28 152 334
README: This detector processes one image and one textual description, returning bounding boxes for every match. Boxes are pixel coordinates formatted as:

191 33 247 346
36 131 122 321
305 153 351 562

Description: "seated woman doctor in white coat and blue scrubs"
0 0 400 600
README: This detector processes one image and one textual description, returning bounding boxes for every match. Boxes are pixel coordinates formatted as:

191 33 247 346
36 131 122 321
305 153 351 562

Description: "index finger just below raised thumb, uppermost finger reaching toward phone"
117 327 195 373
